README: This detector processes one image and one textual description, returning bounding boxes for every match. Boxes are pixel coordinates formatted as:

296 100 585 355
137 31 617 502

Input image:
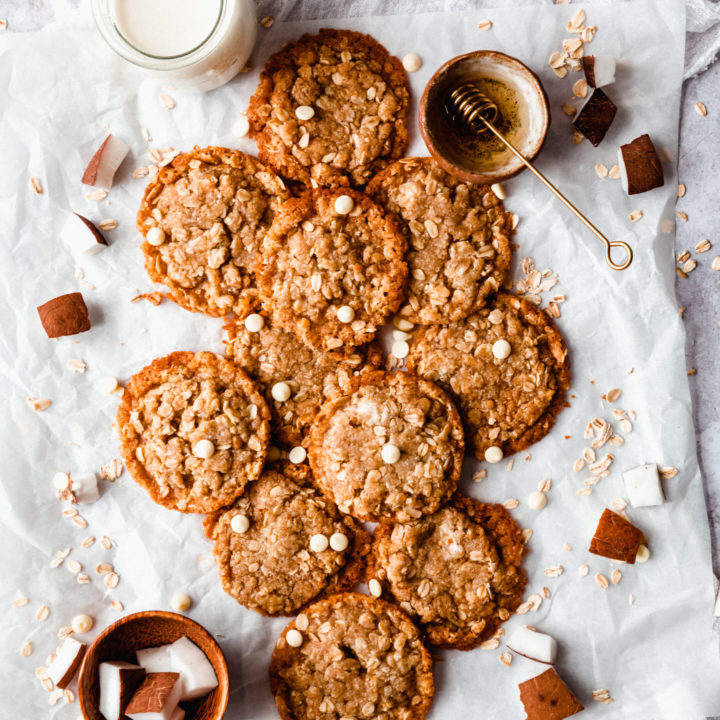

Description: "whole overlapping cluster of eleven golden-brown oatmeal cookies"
117 30 569 720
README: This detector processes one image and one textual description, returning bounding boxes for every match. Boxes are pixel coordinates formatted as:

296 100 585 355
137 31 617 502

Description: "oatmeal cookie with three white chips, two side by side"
205 463 370 615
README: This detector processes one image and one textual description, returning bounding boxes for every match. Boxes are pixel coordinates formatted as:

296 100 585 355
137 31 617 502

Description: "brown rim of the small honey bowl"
418 50 550 183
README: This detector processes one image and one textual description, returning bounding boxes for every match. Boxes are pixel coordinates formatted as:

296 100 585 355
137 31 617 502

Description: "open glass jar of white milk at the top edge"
92 0 257 92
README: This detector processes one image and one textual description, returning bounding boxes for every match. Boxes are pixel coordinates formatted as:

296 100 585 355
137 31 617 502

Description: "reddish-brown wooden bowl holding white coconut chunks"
78 610 230 720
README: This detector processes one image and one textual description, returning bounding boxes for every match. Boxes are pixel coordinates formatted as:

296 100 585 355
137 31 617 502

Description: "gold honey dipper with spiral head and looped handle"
445 82 633 270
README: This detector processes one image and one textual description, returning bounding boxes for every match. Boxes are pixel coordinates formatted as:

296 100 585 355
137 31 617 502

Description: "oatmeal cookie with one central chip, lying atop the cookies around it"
308 371 464 522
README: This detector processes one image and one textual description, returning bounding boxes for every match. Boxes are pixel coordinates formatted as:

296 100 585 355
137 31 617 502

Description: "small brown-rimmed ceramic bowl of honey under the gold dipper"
419 50 550 183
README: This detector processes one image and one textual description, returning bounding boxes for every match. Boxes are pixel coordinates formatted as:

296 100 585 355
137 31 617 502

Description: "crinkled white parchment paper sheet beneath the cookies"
0 1 720 720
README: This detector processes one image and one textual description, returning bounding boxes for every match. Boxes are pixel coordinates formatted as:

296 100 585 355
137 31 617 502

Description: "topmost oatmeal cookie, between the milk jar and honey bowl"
248 29 410 188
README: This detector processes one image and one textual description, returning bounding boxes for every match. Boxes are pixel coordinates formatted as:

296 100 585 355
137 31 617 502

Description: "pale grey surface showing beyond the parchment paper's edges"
0 0 720 564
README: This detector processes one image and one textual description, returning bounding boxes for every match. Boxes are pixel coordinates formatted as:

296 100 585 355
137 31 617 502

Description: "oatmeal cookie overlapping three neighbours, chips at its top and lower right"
256 189 407 354
